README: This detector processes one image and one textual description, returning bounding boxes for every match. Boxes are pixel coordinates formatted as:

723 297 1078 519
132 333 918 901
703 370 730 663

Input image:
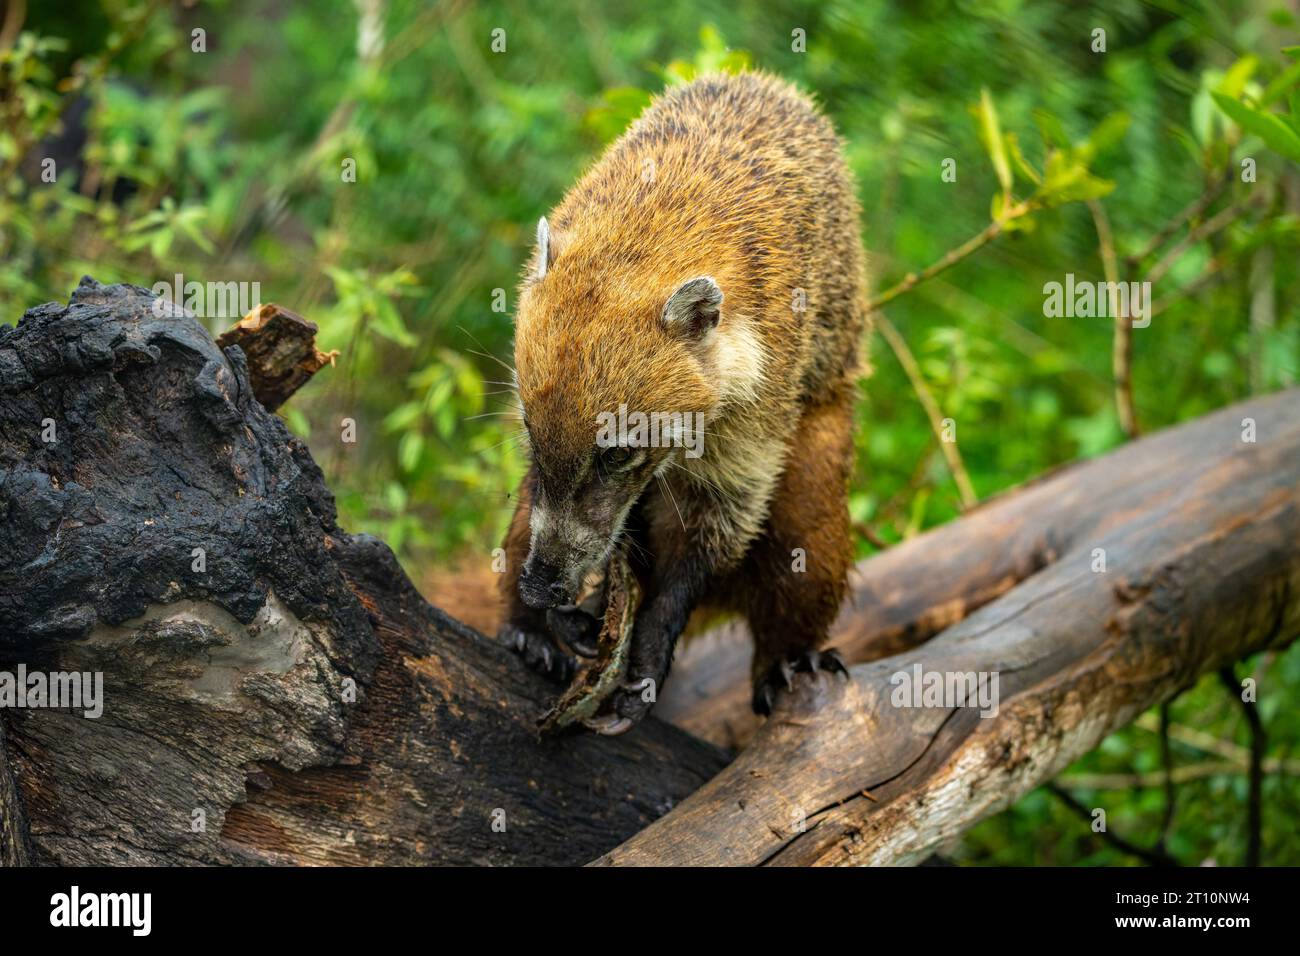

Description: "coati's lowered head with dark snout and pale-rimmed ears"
515 219 754 607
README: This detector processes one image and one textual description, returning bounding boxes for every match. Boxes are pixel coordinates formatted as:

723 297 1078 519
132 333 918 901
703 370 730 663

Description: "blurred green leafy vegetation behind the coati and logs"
0 0 1300 864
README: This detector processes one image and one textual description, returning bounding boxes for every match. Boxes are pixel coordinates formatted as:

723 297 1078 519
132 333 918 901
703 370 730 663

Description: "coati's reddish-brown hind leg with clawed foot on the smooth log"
737 384 853 714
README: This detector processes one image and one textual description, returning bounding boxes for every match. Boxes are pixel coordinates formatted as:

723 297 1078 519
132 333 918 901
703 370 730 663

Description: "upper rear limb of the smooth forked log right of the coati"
655 392 1300 748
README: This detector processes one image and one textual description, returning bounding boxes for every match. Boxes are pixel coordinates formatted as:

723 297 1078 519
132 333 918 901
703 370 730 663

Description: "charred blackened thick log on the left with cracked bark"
0 280 725 864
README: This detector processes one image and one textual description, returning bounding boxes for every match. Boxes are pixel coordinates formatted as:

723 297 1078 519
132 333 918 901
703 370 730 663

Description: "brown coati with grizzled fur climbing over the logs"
501 73 867 734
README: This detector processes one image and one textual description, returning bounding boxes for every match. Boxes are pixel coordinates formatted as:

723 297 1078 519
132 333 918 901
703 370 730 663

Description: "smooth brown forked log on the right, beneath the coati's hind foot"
621 390 1300 865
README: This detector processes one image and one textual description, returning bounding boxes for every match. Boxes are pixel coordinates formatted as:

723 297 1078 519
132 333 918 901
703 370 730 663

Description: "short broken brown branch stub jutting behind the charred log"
217 303 338 411
